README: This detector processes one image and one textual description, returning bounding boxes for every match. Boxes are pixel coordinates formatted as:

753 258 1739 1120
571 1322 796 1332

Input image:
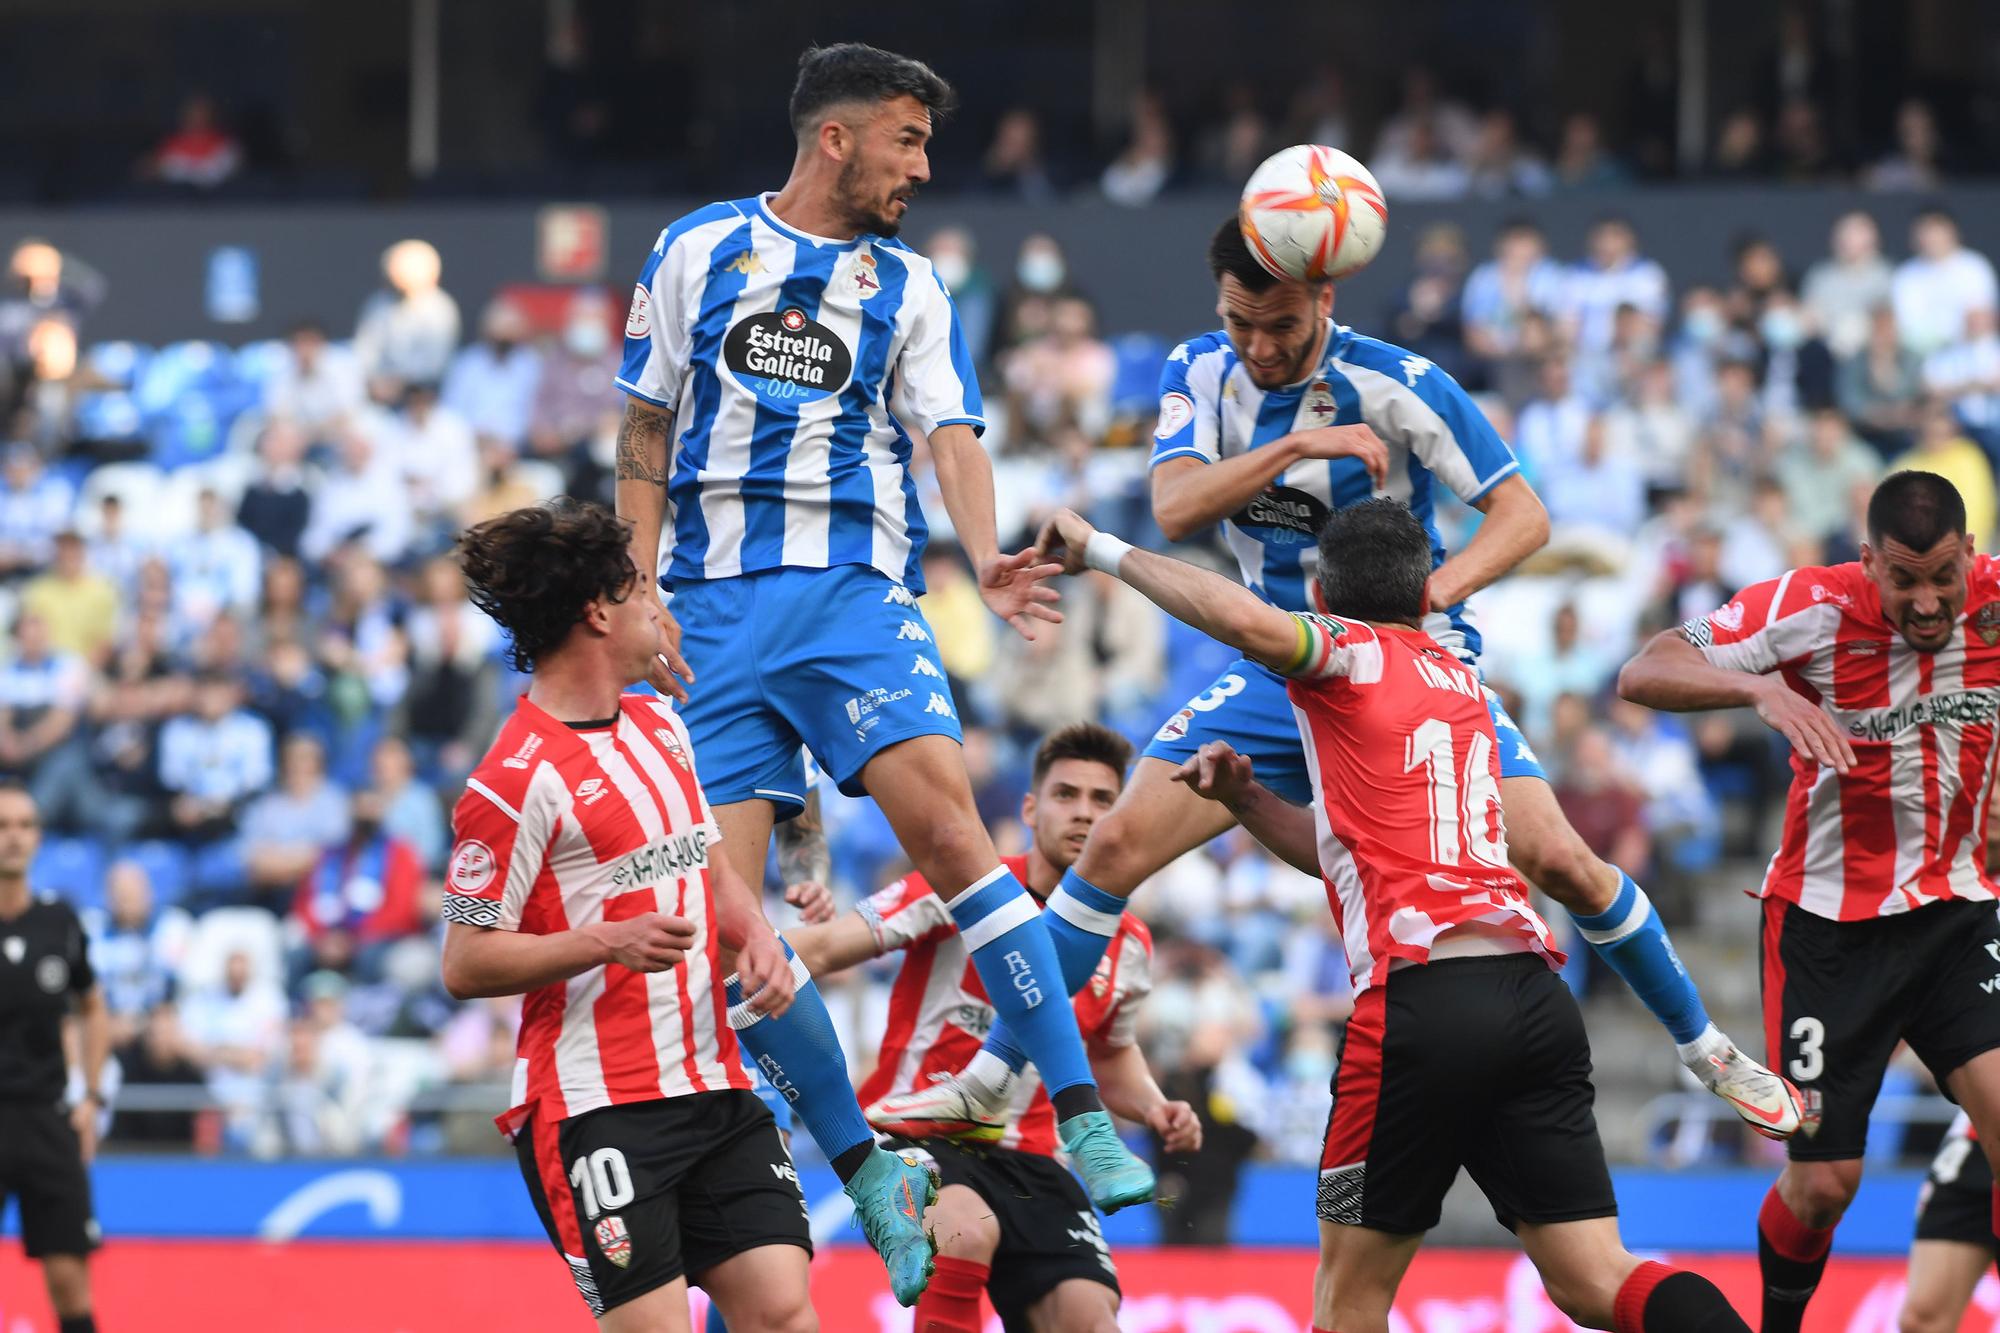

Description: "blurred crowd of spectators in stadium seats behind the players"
0 192 1976 1161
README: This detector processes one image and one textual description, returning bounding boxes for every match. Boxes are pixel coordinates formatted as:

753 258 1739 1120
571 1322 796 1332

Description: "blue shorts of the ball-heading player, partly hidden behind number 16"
1146 658 1548 805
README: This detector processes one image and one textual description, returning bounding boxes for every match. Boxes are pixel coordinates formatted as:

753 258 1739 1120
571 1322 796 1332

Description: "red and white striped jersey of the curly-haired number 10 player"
444 695 750 1129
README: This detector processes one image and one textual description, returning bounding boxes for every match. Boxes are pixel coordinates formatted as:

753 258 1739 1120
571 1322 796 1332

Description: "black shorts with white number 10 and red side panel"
514 1091 812 1315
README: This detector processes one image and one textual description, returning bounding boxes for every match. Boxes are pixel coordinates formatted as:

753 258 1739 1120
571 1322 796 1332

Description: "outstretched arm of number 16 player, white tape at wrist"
1036 508 1298 669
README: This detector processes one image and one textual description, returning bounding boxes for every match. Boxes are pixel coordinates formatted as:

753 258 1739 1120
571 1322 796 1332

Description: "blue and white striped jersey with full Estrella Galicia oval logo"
618 196 986 592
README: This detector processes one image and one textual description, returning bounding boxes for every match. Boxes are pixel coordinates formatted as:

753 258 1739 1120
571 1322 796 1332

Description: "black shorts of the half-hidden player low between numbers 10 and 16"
890 1139 1118 1333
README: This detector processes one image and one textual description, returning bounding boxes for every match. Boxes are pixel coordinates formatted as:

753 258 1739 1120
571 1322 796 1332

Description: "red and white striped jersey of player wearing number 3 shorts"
1680 554 2000 921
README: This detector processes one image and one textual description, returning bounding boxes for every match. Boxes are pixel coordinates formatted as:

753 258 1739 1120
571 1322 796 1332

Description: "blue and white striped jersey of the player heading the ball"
1152 324 1520 658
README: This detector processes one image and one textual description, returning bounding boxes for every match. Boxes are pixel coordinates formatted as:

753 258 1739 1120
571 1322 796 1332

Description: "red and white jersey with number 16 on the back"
1284 614 1562 995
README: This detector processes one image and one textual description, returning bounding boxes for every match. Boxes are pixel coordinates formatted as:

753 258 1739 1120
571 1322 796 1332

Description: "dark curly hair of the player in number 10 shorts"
458 498 638 671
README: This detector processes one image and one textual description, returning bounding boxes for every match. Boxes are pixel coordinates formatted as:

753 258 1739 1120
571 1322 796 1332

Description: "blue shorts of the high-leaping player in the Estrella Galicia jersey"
672 564 964 819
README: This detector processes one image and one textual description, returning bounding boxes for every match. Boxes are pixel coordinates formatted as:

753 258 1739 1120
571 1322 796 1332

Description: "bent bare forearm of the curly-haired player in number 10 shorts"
444 913 694 999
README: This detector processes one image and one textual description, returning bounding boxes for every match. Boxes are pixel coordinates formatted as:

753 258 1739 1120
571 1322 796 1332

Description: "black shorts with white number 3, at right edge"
1764 899 2000 1161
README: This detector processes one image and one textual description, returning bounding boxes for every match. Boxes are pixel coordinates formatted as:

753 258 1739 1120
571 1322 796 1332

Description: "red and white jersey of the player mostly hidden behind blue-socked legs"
856 857 1152 1157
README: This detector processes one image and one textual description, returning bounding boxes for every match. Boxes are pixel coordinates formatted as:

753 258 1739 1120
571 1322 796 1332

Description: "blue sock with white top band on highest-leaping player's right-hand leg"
950 867 1104 1115
